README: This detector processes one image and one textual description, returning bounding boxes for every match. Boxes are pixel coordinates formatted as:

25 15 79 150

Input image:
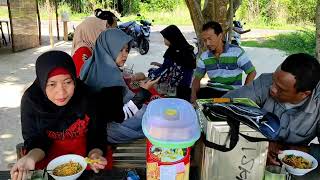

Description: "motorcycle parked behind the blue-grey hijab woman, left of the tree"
118 14 152 55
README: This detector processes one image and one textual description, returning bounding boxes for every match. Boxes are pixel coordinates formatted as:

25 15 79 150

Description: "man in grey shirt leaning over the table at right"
224 53 320 164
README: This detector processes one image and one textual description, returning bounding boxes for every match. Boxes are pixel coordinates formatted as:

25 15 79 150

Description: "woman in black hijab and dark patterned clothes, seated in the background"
149 25 196 101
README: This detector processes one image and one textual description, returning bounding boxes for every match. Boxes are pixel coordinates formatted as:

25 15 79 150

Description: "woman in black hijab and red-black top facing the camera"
10 51 108 180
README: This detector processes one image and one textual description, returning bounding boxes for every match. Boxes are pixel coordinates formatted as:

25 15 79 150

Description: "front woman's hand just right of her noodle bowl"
88 149 108 173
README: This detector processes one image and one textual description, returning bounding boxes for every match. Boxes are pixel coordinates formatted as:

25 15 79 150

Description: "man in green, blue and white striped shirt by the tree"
191 21 256 103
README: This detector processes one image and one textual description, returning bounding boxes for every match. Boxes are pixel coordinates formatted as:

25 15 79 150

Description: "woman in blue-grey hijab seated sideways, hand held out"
80 29 157 143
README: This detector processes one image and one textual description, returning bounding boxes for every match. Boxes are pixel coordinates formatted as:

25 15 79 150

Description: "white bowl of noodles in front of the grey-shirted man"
278 150 318 176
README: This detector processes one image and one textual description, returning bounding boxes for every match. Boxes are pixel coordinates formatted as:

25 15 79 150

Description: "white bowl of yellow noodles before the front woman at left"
47 154 87 180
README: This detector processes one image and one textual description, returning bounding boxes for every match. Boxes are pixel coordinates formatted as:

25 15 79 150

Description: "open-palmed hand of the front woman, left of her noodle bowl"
10 155 36 180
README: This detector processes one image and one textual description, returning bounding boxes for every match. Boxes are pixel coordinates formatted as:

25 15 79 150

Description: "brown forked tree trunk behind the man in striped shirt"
185 0 242 50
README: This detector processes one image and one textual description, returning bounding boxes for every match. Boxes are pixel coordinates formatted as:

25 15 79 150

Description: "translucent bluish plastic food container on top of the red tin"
142 98 200 148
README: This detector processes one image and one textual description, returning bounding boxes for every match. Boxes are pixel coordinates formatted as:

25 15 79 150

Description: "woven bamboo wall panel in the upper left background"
8 0 40 51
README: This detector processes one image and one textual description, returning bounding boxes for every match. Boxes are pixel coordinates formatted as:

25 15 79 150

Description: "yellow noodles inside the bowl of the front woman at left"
53 161 82 176
